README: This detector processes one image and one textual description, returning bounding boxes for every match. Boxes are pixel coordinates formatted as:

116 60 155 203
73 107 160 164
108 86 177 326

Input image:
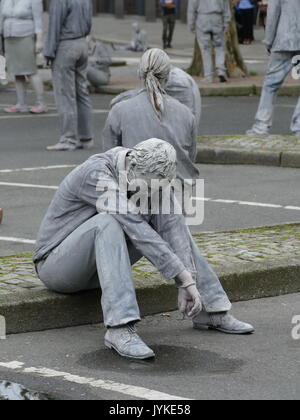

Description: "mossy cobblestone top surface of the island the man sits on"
0 225 300 294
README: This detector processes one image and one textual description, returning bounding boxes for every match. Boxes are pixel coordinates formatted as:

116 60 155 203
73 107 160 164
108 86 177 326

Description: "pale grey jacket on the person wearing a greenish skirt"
0 0 43 38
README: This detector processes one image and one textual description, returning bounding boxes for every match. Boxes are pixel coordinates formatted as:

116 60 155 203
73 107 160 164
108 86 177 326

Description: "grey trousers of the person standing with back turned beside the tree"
197 14 226 78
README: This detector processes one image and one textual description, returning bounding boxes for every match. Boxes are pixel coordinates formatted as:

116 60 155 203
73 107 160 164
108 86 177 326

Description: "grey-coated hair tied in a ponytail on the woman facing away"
139 48 171 119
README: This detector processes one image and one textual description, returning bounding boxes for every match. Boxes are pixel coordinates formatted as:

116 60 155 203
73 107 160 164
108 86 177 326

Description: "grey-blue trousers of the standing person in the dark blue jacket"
53 38 93 144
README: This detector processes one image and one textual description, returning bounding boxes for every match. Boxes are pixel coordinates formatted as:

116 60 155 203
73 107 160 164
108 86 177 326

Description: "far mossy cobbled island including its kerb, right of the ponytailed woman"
197 135 300 168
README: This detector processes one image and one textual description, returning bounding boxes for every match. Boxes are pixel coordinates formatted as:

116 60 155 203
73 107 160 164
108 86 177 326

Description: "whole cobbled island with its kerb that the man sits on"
0 225 300 333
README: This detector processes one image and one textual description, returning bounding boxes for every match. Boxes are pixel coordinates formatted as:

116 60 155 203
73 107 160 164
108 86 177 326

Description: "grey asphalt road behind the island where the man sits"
0 91 300 255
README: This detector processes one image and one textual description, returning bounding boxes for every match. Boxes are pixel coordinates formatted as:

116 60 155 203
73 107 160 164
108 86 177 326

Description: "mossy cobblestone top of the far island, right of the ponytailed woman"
199 135 300 152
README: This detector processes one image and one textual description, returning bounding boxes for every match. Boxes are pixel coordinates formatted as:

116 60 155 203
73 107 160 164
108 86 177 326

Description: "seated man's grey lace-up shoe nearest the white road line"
104 325 155 360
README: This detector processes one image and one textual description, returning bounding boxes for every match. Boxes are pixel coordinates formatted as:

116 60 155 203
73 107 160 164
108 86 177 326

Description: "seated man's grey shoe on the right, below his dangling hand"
193 312 255 334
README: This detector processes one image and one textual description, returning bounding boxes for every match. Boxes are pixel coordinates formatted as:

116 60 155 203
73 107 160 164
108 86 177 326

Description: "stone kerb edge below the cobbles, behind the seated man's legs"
0 258 300 334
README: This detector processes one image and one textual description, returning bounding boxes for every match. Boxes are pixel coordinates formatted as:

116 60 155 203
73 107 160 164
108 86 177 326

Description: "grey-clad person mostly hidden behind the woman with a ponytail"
110 66 202 135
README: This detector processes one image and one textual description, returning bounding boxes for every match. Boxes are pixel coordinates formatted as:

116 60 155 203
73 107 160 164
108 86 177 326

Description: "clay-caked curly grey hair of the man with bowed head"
128 139 177 181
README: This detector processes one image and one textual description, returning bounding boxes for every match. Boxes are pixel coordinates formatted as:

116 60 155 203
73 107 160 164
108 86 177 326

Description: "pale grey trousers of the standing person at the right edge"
254 51 300 133
